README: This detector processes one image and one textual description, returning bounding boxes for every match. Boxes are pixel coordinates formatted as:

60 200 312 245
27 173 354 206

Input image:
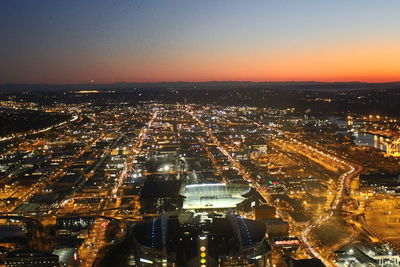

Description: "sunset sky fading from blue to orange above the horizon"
0 0 400 83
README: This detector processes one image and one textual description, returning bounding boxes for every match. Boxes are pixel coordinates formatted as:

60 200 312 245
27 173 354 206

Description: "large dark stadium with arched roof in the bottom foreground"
133 212 271 267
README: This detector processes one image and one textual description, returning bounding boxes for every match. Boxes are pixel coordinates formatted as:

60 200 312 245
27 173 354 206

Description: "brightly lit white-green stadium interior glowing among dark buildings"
180 183 250 210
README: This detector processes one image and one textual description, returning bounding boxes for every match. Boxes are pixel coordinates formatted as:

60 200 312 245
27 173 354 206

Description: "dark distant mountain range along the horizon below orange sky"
0 81 400 92
